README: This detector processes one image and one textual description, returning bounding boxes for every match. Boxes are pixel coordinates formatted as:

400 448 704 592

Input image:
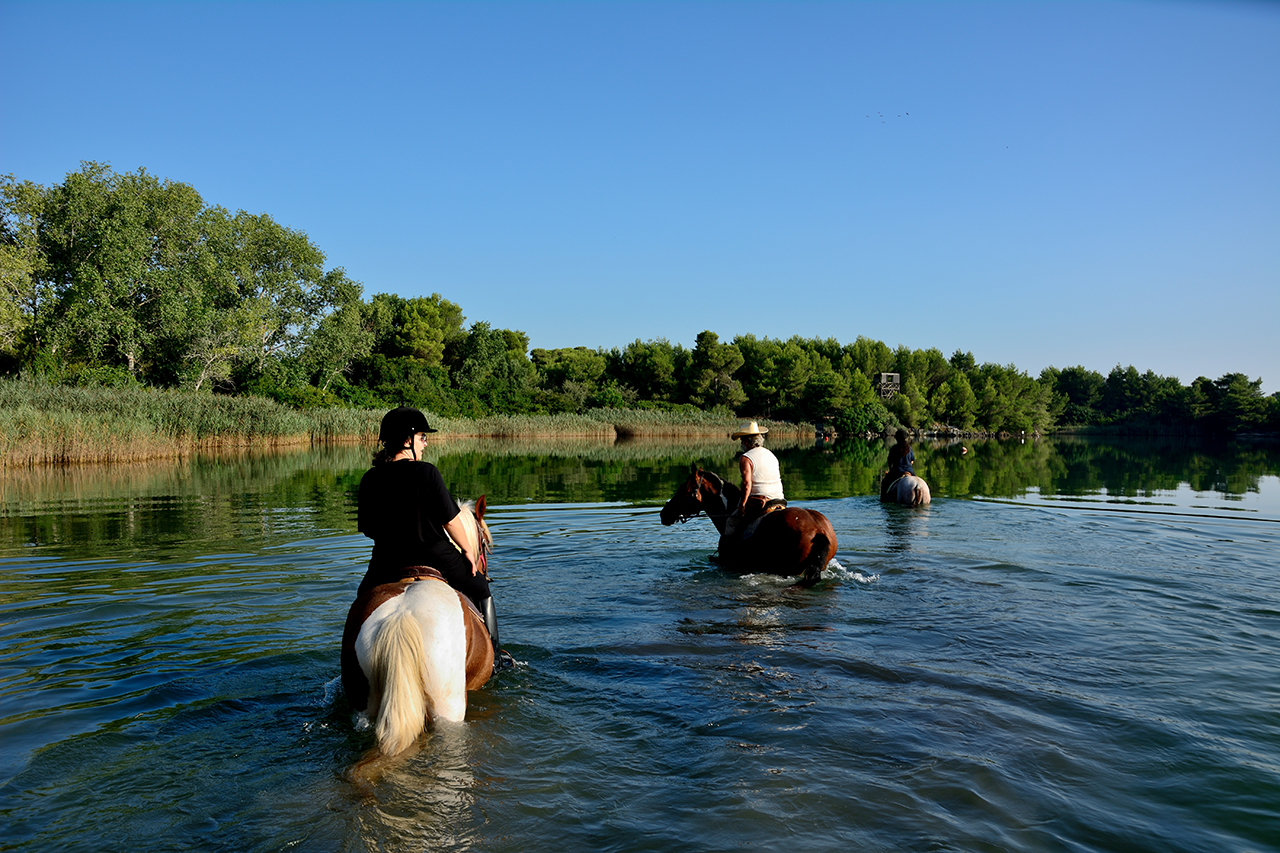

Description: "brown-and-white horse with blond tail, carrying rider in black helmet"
342 497 493 756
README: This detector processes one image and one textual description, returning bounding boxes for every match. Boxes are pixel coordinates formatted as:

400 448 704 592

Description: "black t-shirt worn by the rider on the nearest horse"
357 460 466 583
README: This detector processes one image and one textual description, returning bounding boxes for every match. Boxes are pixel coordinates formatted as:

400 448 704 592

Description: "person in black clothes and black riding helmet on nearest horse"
357 406 513 670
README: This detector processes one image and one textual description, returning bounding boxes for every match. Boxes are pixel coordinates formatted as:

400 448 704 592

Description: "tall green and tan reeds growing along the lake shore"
0 379 813 467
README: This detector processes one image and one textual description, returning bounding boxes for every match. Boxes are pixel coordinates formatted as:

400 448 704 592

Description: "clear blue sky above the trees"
0 0 1280 393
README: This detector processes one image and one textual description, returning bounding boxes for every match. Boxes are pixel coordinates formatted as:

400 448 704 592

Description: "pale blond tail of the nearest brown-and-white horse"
370 607 428 756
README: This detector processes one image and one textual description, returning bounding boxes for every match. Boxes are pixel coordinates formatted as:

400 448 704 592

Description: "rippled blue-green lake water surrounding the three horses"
0 438 1280 853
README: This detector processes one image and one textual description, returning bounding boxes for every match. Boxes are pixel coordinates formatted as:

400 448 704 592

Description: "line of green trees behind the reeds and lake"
0 163 1280 433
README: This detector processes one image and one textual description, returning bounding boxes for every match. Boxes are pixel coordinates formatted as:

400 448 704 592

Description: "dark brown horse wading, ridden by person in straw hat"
662 465 836 587
